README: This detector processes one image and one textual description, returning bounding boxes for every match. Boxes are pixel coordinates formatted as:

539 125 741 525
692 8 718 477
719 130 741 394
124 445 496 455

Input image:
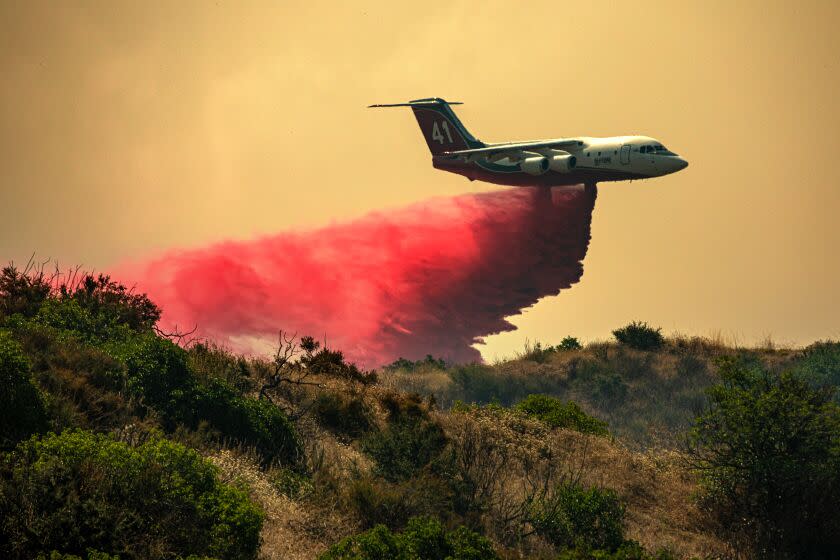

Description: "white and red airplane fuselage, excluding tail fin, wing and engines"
432 136 688 187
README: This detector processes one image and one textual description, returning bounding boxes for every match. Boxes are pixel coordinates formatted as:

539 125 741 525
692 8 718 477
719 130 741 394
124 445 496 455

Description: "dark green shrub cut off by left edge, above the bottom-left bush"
0 330 47 448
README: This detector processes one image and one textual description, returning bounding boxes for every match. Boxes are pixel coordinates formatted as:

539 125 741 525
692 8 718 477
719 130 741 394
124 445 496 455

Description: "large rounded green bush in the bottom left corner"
0 430 263 559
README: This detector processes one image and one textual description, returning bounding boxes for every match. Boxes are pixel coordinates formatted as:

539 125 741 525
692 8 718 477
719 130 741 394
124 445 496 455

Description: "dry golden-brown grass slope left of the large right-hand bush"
438 410 728 558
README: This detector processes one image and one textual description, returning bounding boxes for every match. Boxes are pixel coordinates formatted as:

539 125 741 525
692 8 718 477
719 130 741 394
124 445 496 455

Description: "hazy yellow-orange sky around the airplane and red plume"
0 1 840 358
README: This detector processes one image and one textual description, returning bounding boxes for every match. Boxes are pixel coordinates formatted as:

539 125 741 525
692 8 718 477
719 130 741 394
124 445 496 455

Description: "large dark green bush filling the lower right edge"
691 357 840 558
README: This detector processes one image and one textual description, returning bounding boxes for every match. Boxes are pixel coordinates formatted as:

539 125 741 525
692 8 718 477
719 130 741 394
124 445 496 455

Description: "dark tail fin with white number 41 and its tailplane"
369 97 484 155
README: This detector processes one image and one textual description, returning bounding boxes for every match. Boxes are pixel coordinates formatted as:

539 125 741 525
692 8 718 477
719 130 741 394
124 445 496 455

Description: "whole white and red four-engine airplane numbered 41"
370 97 688 187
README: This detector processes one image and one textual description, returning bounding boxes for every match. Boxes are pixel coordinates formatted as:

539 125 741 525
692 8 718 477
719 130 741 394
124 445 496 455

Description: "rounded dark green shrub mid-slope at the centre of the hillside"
362 419 446 482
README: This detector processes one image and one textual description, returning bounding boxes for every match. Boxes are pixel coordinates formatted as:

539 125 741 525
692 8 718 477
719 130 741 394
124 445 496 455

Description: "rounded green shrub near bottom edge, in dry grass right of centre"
529 483 625 551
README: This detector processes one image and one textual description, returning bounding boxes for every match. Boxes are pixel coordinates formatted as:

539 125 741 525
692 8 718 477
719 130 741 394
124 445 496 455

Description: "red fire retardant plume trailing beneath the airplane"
115 188 596 367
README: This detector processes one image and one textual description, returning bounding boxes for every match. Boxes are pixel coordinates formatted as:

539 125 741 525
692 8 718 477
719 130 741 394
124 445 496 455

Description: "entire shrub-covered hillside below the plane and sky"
0 267 840 559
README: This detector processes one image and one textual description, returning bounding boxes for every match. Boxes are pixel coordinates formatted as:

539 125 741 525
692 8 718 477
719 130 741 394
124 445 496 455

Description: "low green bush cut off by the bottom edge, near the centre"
320 517 498 560
